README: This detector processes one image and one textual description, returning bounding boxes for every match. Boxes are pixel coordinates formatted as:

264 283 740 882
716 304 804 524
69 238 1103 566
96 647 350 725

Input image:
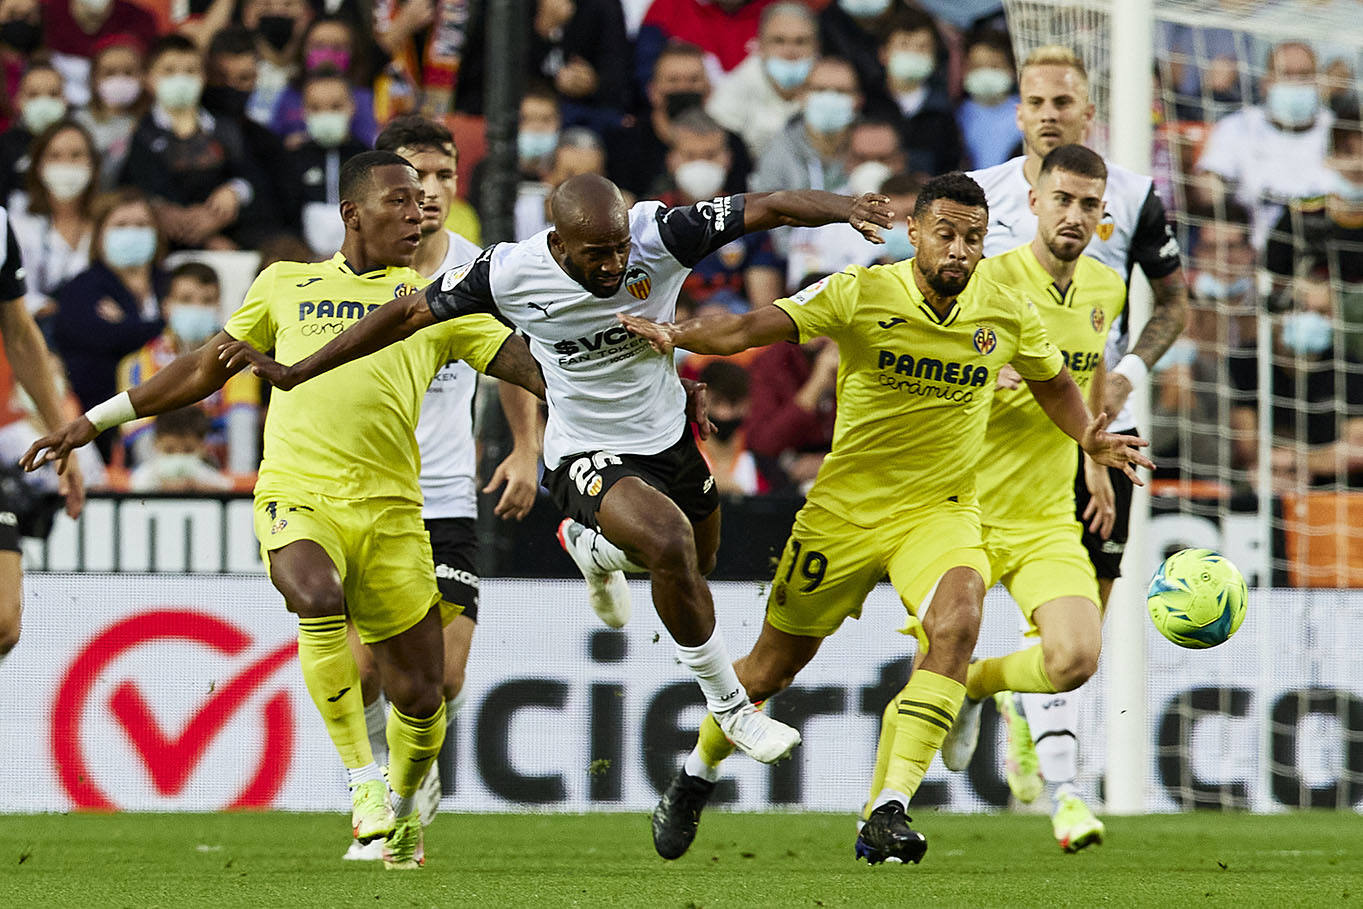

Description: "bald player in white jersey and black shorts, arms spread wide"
225 174 894 763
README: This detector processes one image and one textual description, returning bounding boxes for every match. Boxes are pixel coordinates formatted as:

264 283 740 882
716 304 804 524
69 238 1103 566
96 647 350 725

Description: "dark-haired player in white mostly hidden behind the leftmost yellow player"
343 114 540 861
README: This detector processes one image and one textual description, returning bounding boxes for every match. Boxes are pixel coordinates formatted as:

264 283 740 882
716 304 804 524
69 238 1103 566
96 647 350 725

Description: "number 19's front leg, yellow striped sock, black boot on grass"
856 567 984 864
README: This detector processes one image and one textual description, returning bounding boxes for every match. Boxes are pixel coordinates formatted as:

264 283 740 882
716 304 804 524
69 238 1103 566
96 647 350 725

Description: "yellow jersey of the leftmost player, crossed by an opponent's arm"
225 253 511 504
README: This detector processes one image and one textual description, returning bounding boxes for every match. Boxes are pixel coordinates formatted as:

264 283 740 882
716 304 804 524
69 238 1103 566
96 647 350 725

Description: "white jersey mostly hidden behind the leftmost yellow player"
417 230 483 518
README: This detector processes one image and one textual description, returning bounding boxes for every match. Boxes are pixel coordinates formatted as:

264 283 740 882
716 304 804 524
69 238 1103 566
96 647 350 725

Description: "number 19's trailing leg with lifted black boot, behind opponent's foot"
653 620 823 859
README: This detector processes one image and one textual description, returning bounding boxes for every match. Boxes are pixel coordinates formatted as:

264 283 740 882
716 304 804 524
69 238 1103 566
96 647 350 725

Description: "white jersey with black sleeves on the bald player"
425 196 743 469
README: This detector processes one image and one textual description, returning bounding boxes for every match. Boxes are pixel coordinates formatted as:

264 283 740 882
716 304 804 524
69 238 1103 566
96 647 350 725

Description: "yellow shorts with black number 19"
766 502 990 649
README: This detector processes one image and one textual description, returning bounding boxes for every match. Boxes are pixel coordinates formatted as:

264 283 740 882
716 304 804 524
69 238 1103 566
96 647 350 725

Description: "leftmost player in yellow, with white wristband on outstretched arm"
23 151 542 868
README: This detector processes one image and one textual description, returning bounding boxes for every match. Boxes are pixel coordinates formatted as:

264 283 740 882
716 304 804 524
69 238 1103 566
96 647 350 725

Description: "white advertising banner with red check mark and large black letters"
0 574 1363 812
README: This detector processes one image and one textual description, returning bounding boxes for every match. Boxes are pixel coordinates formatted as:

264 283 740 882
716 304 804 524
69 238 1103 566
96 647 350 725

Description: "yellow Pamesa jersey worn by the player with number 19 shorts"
776 259 1063 527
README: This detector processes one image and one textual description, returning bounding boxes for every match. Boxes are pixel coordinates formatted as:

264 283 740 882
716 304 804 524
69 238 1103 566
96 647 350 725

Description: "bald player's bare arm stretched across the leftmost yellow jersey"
214 290 436 391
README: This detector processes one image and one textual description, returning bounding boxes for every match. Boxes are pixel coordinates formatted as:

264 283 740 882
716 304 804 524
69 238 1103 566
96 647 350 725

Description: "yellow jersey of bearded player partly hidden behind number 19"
976 244 1126 526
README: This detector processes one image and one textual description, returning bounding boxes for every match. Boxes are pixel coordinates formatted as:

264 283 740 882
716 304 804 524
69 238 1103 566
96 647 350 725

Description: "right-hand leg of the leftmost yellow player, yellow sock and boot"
369 605 444 869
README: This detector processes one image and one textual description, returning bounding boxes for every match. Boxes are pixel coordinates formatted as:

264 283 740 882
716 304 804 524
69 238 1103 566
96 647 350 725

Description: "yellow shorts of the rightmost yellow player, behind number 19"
984 518 1099 638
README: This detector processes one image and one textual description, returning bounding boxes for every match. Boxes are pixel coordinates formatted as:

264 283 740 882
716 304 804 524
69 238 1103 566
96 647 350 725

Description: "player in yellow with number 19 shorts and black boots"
620 173 1149 863
